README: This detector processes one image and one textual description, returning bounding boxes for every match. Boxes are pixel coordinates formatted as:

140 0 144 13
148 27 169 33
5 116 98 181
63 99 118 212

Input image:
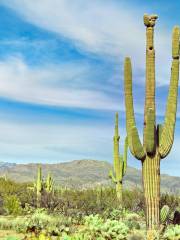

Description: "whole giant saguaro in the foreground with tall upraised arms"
124 15 180 230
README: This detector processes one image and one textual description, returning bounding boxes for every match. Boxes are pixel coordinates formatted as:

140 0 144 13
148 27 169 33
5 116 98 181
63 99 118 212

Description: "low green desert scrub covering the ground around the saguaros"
0 174 180 240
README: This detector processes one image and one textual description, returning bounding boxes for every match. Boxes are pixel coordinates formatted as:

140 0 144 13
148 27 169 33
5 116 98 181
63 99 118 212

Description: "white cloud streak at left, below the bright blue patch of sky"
0 58 119 110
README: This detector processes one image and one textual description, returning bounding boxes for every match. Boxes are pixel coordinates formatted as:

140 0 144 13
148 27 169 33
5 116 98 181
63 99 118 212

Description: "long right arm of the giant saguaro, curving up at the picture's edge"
159 27 180 158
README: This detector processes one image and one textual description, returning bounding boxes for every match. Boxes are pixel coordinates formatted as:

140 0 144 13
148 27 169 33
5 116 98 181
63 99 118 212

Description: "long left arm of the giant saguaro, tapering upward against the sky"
124 58 145 160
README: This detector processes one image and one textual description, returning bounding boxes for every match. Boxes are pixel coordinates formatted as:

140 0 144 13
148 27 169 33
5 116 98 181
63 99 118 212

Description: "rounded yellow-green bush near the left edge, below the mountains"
3 195 22 215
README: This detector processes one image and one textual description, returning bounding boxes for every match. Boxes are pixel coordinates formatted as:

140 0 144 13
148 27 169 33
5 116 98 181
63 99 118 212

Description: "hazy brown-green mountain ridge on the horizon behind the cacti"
0 160 180 194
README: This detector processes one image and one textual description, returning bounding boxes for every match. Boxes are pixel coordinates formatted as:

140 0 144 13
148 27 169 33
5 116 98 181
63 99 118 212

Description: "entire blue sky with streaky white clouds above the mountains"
0 0 180 176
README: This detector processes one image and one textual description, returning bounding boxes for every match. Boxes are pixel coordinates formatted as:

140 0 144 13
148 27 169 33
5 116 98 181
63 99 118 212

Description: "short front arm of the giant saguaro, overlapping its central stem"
144 108 155 153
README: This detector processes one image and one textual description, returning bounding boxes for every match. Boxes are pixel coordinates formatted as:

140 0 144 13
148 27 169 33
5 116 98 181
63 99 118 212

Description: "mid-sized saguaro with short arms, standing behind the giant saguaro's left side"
109 113 128 203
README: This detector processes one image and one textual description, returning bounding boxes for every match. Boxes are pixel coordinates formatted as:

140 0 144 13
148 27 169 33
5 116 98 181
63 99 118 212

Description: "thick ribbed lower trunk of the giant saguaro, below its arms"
142 152 160 230
